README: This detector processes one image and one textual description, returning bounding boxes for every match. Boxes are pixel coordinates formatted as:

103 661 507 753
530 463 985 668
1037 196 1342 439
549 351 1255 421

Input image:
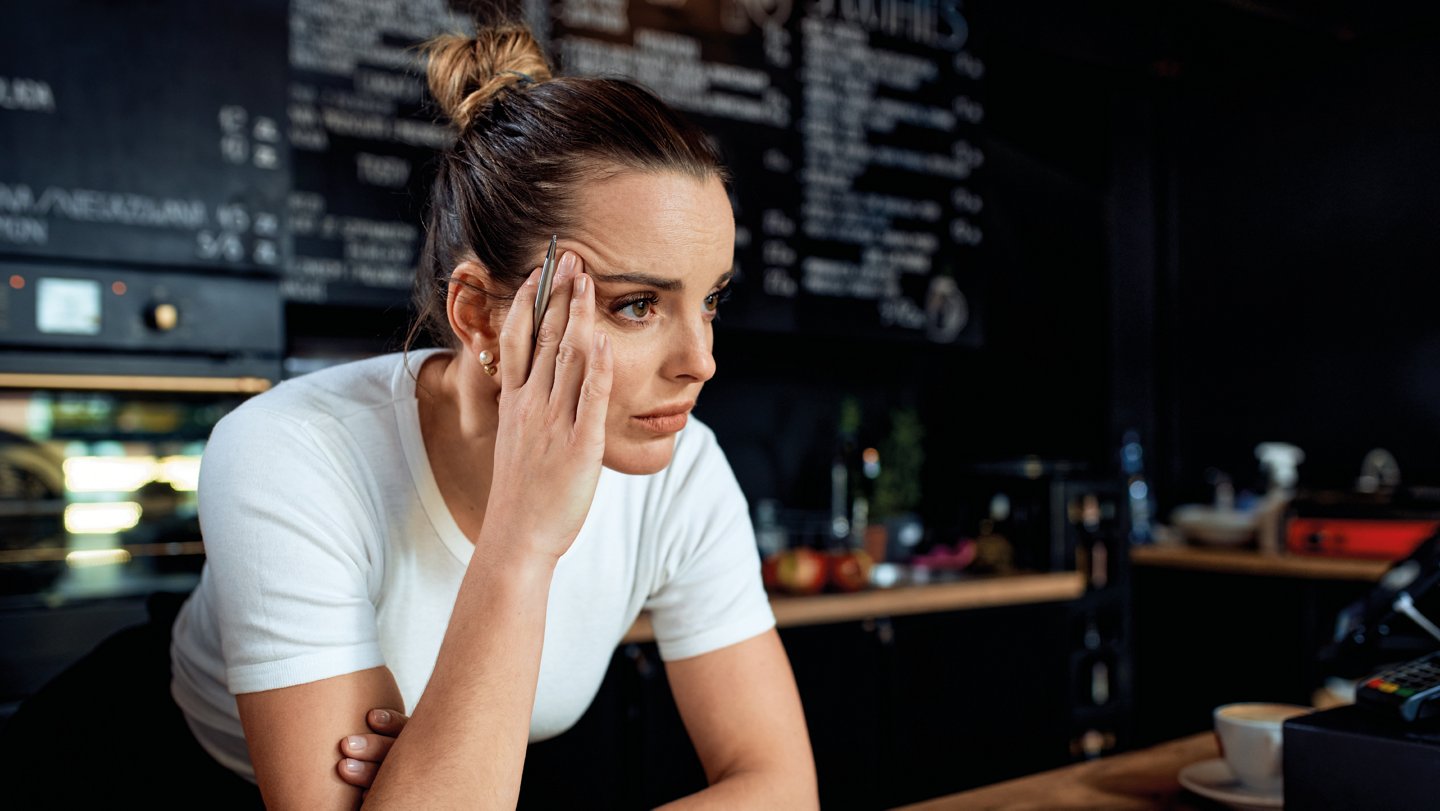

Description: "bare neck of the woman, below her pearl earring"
415 353 500 543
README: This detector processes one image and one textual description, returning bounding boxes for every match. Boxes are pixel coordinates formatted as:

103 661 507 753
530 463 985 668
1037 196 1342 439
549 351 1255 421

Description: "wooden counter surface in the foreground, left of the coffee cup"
903 732 1220 811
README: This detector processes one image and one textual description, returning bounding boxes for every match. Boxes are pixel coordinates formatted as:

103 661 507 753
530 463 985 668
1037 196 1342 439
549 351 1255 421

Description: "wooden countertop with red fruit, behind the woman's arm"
621 572 1084 644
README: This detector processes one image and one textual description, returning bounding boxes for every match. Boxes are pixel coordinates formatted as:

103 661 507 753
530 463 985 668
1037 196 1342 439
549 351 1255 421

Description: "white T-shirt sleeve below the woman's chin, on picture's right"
645 425 775 661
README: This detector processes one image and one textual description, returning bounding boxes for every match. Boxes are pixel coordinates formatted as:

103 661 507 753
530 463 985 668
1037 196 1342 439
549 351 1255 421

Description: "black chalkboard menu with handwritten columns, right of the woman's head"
553 0 985 344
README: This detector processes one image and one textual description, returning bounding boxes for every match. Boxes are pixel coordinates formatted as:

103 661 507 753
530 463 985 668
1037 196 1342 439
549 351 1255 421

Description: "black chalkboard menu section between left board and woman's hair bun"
281 0 474 307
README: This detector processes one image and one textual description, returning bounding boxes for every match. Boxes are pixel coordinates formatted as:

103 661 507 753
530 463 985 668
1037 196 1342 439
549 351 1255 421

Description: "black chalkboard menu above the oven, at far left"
0 0 289 274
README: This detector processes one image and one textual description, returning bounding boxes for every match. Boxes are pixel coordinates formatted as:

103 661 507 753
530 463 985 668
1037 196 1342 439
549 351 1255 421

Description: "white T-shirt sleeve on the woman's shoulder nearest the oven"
199 406 383 694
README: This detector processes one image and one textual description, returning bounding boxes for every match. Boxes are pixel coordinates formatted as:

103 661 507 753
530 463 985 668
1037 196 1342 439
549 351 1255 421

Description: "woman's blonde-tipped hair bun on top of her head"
425 24 550 131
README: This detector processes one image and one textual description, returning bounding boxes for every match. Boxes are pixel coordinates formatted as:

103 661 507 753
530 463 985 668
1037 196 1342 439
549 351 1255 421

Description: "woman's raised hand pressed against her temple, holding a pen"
477 251 613 560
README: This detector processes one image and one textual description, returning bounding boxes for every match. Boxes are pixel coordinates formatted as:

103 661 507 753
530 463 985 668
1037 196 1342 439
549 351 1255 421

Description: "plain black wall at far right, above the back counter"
1158 3 1440 497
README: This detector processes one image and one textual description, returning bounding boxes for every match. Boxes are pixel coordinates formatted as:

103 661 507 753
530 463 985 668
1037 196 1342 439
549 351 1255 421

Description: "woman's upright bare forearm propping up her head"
366 533 554 808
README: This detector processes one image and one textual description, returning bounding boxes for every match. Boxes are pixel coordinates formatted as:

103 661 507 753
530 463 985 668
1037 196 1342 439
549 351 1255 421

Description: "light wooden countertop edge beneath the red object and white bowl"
1130 545 1394 582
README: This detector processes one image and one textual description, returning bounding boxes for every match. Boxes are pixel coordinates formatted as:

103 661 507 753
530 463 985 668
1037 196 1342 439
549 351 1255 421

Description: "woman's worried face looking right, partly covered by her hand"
559 171 734 474
